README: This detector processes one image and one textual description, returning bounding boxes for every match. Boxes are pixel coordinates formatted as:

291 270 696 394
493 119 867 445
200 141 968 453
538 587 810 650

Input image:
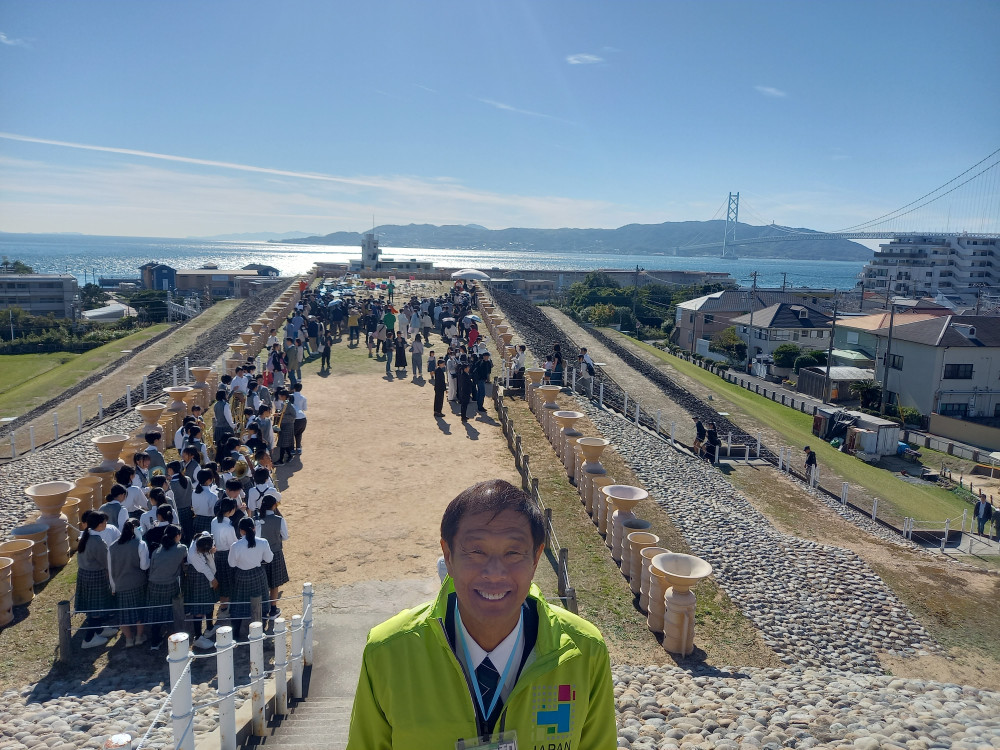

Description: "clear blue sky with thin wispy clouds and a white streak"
0 0 1000 237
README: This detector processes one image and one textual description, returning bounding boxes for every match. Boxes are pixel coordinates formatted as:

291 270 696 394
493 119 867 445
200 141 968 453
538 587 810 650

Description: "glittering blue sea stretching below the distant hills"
0 234 864 289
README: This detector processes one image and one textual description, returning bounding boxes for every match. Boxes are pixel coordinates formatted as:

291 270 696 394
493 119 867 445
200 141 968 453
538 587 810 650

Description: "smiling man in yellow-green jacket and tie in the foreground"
347 479 617 750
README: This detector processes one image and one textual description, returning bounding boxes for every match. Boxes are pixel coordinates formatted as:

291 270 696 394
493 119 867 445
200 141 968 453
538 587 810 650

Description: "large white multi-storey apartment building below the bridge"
862 234 1000 297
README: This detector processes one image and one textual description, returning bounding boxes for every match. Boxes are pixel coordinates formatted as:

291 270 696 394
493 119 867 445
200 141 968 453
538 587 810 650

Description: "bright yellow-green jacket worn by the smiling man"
347 578 618 750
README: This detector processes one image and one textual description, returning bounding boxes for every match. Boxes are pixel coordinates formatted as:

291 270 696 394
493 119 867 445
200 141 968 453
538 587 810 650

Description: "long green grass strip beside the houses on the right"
634 342 969 521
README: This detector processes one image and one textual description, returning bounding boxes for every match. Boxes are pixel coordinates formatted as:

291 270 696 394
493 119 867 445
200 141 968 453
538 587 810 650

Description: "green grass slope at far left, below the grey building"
0 323 170 424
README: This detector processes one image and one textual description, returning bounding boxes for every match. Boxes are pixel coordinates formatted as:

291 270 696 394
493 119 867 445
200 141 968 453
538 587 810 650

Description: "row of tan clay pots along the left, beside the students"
0 282 307 627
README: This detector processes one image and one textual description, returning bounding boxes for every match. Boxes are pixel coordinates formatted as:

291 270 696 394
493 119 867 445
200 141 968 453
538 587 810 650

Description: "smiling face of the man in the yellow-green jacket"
441 510 543 627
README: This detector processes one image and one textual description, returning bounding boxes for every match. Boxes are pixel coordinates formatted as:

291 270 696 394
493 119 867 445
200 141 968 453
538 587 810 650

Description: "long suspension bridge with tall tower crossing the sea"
676 149 1000 258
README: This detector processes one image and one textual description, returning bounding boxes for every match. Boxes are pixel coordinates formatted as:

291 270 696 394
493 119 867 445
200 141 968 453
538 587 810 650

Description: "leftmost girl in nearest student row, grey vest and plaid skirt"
74 510 117 648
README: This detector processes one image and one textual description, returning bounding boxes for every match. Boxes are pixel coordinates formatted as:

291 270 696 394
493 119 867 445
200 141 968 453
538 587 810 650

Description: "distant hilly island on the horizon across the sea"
269 221 872 261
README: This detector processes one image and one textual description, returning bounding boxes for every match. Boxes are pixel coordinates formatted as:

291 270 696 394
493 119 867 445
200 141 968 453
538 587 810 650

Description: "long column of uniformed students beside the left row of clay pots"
75 292 347 650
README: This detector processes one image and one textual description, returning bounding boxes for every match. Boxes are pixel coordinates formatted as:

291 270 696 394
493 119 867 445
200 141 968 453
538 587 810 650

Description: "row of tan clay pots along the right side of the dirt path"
481 294 712 656
